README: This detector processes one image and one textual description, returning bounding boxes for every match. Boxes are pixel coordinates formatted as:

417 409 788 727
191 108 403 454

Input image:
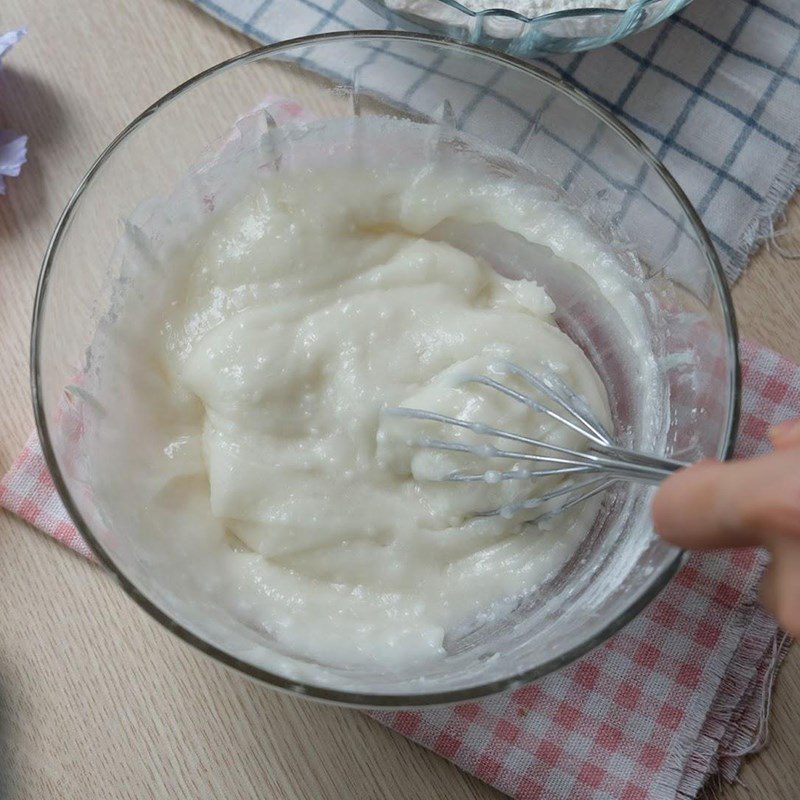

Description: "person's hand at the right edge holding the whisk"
653 419 800 636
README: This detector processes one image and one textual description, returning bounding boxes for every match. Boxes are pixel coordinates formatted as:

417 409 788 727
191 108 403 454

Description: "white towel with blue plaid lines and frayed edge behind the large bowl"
194 0 800 279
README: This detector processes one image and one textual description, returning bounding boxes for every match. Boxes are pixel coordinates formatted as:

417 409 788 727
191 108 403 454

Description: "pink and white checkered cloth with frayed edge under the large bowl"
0 344 800 800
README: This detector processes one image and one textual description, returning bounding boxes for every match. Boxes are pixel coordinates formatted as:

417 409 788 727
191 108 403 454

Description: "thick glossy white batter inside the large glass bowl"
89 126 632 668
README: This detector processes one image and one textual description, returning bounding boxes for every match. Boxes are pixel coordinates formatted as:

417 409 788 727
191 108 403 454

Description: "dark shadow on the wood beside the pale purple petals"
0 66 68 241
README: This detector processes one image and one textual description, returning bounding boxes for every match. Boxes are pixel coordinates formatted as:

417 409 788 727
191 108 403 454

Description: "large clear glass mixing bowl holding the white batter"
31 32 738 706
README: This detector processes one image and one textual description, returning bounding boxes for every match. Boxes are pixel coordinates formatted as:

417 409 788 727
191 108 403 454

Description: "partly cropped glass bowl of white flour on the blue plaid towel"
362 0 691 56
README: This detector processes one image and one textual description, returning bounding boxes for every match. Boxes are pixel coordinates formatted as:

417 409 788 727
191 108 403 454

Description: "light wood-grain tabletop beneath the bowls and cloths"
0 0 800 800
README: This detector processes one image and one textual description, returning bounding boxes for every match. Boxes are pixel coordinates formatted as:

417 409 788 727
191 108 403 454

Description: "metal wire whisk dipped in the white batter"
384 361 687 521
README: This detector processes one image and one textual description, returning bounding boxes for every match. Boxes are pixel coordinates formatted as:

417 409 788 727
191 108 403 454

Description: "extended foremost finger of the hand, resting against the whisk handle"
653 449 800 549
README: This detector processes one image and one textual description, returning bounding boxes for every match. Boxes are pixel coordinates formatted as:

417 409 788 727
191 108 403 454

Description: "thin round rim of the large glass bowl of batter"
30 30 741 708
